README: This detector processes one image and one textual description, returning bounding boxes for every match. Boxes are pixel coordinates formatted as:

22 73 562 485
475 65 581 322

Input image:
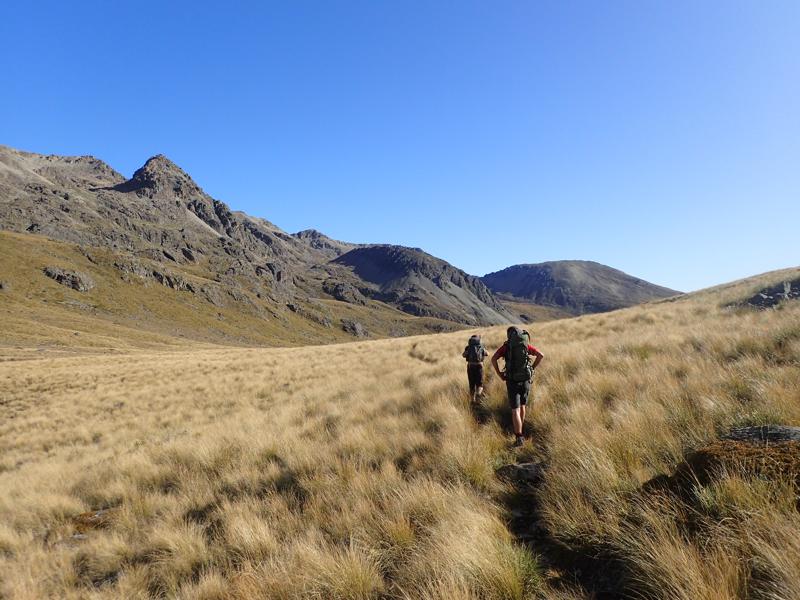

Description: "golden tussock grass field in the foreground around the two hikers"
0 270 800 600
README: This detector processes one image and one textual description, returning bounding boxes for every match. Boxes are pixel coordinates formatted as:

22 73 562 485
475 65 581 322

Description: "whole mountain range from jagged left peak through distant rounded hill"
0 146 688 344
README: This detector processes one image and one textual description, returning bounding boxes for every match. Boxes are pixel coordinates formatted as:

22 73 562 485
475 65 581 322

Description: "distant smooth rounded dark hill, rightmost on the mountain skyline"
481 260 680 314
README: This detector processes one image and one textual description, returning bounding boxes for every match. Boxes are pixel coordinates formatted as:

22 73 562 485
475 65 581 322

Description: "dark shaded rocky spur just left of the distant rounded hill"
333 245 513 325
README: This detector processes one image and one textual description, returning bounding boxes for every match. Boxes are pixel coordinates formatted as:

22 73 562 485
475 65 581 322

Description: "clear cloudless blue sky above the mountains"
0 0 800 290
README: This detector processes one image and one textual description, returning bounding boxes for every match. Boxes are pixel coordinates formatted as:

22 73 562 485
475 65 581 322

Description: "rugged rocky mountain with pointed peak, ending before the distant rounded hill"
0 141 512 343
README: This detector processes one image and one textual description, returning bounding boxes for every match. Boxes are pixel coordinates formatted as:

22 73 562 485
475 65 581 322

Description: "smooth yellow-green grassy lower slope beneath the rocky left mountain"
0 231 460 357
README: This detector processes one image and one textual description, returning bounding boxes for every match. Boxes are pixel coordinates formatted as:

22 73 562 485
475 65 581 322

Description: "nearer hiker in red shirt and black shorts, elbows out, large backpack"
492 327 544 446
